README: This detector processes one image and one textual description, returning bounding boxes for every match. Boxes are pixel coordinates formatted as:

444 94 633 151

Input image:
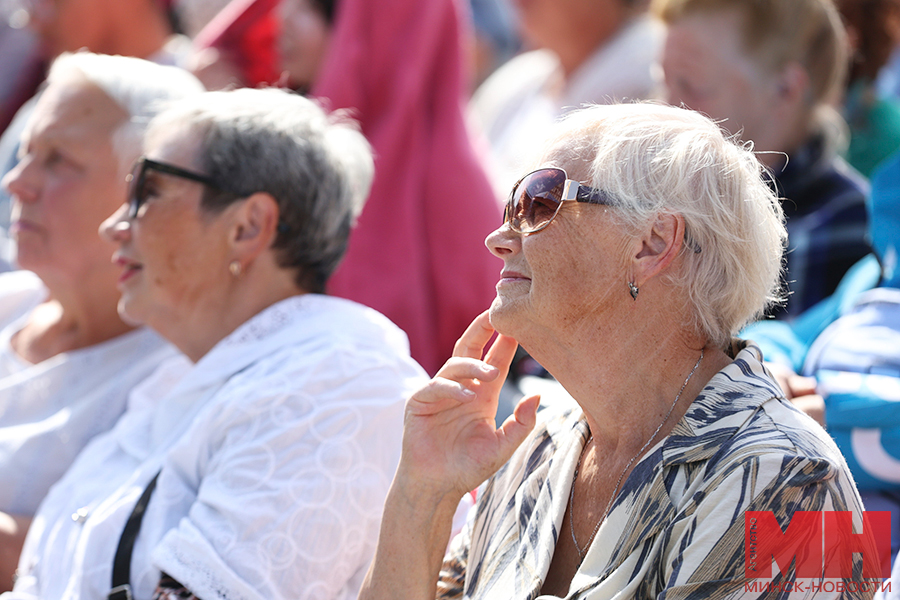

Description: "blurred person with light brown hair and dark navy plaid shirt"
653 0 870 317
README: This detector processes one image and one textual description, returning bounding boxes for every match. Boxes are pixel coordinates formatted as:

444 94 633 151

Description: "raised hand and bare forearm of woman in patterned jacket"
359 312 540 600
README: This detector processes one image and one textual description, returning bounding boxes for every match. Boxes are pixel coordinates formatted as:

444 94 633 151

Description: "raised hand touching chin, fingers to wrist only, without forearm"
398 312 540 500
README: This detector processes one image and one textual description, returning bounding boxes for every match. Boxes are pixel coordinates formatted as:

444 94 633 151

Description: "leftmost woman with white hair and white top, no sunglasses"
0 53 202 589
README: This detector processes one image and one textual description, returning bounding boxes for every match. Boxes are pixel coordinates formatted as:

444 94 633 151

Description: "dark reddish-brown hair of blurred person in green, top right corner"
837 0 900 83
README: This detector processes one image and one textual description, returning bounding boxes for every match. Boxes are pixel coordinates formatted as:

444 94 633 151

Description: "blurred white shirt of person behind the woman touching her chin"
469 16 663 200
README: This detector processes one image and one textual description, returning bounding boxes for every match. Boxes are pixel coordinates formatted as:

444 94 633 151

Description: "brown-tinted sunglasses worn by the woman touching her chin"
503 167 700 254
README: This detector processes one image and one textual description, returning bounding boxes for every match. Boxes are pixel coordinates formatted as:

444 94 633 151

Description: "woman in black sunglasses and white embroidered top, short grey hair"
4 85 426 600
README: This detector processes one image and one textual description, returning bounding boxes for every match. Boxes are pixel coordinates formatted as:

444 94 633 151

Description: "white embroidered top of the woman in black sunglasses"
6 295 427 600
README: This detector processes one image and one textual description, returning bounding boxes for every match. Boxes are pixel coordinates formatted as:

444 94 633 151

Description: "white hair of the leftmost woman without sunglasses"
47 52 204 172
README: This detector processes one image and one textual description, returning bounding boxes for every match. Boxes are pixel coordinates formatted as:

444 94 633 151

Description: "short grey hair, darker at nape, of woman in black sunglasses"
148 89 372 293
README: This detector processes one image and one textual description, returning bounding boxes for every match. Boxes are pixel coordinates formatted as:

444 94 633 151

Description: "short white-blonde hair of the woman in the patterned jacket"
545 103 787 348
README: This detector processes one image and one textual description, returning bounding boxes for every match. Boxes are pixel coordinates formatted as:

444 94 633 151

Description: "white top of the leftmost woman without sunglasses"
0 271 177 517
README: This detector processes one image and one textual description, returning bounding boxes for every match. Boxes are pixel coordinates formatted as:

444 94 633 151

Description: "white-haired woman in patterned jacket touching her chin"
360 104 862 600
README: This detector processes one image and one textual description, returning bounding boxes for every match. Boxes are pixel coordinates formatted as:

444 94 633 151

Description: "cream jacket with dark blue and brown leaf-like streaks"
438 340 874 600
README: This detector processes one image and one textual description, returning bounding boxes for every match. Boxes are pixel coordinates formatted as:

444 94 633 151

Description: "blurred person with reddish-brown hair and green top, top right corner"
837 0 900 177
